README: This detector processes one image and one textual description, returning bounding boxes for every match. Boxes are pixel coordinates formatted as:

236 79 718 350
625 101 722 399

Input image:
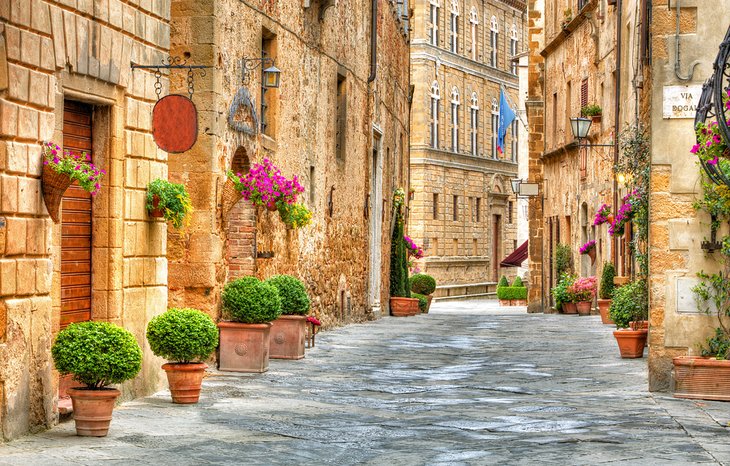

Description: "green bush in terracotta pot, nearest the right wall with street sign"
609 280 649 358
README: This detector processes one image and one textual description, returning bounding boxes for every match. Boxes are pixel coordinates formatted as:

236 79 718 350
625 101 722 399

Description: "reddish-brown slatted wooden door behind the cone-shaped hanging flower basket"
61 101 93 328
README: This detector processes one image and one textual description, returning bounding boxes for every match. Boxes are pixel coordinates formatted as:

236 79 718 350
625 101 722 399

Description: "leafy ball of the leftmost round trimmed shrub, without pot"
51 322 142 388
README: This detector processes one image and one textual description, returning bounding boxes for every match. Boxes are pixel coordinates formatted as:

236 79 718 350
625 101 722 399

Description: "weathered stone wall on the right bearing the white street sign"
649 0 730 390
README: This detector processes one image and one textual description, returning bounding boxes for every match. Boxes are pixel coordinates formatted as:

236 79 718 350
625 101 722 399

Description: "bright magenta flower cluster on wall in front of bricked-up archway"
236 159 304 209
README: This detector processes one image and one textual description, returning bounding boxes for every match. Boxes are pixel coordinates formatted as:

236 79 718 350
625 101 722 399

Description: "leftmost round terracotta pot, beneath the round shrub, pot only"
68 388 121 437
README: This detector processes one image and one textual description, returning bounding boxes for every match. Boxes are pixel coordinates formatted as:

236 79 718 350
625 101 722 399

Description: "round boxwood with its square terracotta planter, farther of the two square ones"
266 275 310 359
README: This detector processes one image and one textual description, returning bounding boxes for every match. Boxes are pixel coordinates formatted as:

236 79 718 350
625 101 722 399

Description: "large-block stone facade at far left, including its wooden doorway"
0 0 169 439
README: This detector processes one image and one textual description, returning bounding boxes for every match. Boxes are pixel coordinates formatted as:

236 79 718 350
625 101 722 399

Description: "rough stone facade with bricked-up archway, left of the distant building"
168 0 410 325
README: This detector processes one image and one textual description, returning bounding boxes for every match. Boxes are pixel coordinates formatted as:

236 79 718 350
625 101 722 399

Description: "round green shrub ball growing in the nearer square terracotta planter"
221 277 281 324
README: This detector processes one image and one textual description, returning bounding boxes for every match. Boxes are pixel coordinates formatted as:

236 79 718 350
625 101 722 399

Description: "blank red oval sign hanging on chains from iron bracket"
152 94 198 153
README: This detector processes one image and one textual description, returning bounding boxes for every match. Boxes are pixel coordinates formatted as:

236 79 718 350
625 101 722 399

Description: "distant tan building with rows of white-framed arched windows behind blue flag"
408 0 527 294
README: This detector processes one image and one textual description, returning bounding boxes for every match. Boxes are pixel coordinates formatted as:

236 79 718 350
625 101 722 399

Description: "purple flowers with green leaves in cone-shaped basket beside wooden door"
43 142 106 196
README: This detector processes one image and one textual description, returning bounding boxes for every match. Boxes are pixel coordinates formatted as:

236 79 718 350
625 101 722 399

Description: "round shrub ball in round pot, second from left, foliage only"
147 308 218 362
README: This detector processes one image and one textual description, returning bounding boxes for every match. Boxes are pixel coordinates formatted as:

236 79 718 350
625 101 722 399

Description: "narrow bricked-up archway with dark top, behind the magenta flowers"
225 146 256 280
